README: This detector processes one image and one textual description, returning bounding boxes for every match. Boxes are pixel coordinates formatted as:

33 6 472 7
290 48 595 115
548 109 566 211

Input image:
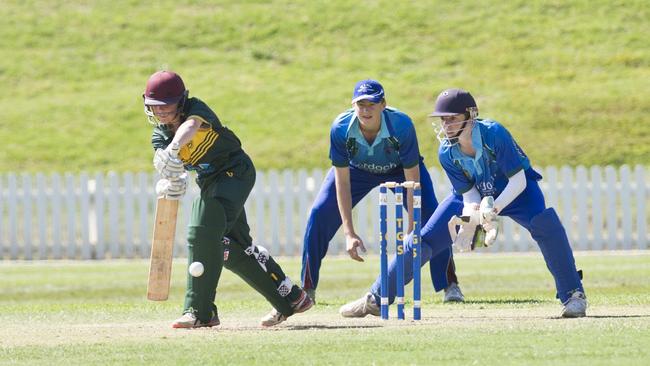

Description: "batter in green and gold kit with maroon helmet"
143 71 313 328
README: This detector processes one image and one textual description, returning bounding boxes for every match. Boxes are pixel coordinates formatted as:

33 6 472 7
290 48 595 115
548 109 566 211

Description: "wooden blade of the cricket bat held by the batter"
147 198 178 301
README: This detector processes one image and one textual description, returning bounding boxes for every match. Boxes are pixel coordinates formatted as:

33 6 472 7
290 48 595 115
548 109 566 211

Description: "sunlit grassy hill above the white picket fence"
0 0 650 172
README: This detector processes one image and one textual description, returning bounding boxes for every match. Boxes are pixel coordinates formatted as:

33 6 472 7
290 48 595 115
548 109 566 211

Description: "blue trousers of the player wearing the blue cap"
301 161 451 291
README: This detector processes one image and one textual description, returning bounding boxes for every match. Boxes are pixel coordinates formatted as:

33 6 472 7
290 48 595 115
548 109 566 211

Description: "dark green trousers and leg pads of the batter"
184 157 301 322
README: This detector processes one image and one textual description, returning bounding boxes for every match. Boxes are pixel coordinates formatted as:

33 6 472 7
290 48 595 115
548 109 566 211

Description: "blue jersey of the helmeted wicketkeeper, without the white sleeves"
438 119 542 197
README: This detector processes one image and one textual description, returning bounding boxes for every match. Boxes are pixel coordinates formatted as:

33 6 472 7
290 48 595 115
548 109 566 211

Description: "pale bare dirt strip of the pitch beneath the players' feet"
0 306 650 348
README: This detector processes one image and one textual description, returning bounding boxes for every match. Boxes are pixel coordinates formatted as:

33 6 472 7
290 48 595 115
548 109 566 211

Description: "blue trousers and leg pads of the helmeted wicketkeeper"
370 179 584 304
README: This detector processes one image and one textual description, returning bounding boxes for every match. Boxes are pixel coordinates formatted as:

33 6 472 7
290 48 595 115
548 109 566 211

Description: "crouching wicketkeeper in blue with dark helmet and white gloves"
341 89 587 318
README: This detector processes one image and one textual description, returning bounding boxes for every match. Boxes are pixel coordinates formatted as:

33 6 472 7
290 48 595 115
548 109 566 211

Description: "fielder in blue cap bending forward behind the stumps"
302 80 463 301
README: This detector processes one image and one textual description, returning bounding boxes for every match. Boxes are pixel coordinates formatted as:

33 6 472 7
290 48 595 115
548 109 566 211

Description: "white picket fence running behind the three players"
0 165 650 260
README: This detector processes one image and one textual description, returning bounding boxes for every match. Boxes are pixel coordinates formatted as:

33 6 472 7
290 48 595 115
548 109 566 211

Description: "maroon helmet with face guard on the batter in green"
142 71 189 130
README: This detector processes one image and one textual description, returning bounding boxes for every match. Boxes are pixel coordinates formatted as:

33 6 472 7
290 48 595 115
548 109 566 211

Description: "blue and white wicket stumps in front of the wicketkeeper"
379 181 422 320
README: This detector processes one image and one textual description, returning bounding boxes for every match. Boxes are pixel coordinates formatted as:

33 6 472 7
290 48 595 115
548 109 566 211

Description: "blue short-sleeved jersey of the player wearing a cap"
330 107 420 174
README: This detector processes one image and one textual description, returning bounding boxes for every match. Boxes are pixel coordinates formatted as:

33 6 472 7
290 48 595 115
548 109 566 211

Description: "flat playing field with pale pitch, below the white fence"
0 252 650 366
